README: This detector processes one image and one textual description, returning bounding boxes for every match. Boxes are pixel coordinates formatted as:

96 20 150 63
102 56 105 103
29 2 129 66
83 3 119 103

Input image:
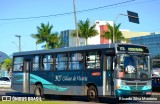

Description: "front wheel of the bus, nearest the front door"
87 86 98 102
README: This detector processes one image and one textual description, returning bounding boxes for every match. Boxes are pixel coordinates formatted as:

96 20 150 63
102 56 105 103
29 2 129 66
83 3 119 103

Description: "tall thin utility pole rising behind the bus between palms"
73 0 79 46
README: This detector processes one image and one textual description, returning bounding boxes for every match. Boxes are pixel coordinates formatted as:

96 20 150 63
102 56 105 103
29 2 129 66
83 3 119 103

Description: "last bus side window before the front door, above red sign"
86 51 101 69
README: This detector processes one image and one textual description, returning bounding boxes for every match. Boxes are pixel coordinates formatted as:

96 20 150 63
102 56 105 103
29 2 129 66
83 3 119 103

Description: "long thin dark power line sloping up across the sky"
0 0 135 21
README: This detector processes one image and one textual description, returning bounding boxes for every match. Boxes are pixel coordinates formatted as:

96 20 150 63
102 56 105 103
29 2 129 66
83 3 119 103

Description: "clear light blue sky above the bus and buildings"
0 0 160 56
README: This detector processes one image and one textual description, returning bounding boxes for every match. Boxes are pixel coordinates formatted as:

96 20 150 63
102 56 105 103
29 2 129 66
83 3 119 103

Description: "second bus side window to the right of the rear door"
42 55 53 70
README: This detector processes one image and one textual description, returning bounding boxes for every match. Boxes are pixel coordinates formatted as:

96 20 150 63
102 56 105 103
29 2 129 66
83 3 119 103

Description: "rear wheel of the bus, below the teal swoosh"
34 84 44 97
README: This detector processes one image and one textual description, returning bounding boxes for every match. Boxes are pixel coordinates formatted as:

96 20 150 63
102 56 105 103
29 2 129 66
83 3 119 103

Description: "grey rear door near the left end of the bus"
23 58 31 93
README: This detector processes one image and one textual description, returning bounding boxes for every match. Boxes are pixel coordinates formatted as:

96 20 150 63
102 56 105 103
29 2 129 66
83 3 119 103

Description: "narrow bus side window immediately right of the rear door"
33 55 40 71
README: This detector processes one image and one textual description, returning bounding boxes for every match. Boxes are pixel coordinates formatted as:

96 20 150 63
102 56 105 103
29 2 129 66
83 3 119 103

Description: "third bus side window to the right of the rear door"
55 54 67 70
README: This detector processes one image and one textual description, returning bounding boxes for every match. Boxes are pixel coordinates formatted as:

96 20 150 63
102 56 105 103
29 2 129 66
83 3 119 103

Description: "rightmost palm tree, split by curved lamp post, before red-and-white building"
102 24 126 43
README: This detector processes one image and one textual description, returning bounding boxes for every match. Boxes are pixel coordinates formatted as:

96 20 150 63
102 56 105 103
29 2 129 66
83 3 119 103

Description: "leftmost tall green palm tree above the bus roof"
31 23 62 49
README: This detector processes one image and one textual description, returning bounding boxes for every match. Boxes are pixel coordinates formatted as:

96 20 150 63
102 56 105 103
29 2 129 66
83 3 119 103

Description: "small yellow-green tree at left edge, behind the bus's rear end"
2 58 12 73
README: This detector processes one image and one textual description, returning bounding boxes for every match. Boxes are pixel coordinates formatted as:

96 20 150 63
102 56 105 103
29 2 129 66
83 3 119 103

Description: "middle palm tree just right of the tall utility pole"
72 19 98 45
